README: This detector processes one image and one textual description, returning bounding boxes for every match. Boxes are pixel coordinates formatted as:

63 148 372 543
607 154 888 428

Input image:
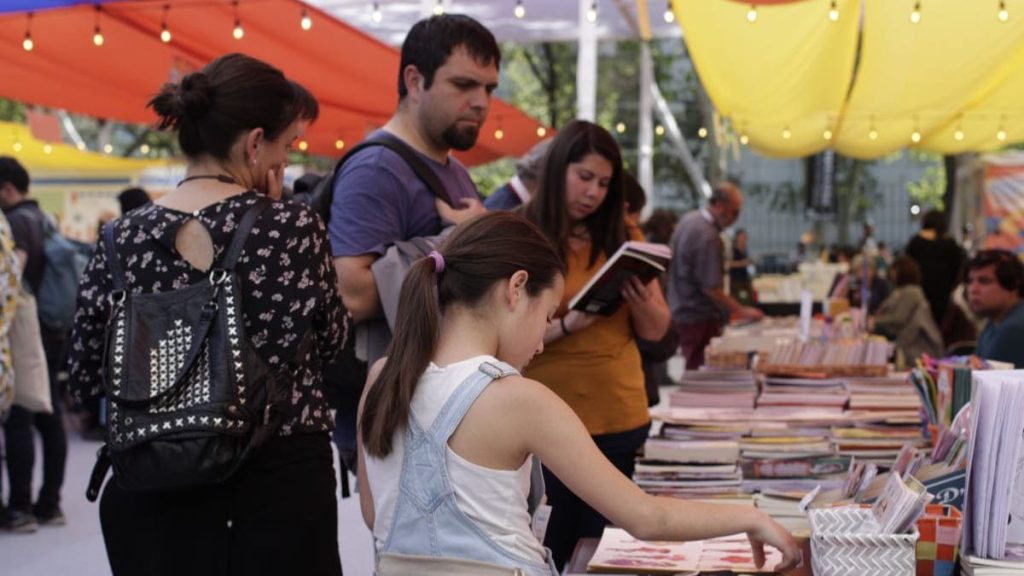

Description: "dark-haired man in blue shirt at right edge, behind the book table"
967 250 1024 368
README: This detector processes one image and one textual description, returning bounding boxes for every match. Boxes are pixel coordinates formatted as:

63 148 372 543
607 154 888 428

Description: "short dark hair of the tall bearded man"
398 14 502 100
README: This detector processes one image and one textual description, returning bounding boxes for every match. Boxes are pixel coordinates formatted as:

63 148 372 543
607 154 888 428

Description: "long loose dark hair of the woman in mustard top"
522 120 626 266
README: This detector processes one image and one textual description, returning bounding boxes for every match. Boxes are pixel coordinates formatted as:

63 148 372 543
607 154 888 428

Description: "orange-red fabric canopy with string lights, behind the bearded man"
0 0 545 165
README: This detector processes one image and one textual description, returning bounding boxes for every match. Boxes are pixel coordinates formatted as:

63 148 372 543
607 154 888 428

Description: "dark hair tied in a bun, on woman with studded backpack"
147 53 319 160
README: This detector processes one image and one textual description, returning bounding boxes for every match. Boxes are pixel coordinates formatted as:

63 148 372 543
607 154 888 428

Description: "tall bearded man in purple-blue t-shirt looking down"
328 14 501 323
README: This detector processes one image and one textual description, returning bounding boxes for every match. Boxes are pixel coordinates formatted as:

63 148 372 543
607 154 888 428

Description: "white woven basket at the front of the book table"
810 506 918 576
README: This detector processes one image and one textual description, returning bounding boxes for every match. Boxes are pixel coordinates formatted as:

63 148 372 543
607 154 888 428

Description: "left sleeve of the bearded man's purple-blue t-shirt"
328 158 403 257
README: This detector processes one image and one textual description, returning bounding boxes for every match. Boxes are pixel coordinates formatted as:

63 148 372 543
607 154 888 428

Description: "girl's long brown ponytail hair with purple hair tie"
359 211 564 458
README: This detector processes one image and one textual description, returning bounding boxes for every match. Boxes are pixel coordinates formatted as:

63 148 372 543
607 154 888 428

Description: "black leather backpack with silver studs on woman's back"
86 198 294 500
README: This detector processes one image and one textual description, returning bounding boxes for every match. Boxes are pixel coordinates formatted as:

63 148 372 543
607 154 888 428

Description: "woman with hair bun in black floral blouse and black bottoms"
70 54 348 576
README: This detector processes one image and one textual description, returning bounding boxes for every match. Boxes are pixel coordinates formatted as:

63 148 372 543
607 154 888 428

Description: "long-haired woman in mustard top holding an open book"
523 120 670 567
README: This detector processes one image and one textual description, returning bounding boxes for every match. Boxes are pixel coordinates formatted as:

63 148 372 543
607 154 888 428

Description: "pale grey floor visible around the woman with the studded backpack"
0 431 373 576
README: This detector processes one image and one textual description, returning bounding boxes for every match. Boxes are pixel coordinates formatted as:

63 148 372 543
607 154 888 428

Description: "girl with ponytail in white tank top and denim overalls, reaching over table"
358 211 799 576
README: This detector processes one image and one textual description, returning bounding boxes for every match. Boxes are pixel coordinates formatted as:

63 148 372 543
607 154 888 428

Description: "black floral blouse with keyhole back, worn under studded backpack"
69 191 351 435
